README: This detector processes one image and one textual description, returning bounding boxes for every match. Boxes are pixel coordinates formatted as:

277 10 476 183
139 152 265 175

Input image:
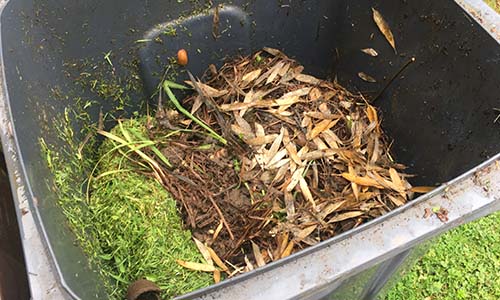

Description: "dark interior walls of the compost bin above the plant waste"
0 0 500 296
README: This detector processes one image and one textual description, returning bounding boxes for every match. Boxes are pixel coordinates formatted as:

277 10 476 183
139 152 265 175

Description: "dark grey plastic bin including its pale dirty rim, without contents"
0 0 500 299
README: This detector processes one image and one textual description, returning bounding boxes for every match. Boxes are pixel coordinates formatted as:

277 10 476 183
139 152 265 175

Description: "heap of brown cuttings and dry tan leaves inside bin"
100 48 428 281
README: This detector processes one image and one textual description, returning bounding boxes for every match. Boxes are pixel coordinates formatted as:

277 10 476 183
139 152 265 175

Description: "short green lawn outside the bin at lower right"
386 213 500 300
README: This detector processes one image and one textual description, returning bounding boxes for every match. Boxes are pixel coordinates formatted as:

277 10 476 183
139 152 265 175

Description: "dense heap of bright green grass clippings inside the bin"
87 118 213 298
